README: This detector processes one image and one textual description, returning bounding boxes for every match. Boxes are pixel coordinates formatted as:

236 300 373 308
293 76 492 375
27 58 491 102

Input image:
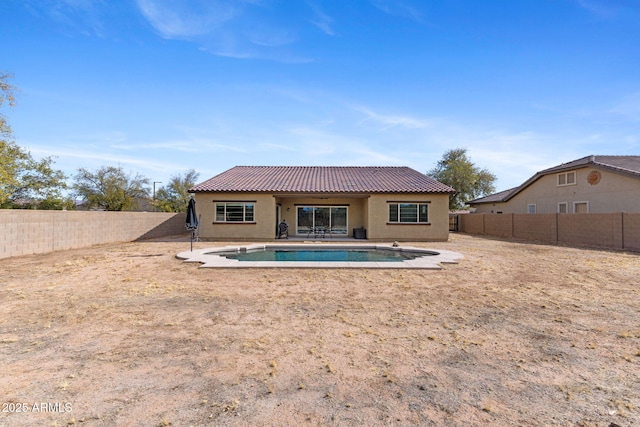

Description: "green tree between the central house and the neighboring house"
427 148 496 211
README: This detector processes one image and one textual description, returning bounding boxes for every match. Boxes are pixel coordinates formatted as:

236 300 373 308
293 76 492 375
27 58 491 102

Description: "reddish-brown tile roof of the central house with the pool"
191 166 455 193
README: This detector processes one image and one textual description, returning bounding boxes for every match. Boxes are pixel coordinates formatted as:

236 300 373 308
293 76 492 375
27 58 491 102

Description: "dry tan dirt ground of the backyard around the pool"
0 234 640 427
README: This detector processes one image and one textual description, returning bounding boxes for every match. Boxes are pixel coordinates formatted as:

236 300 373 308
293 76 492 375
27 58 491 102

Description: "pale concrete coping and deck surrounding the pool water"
176 243 464 270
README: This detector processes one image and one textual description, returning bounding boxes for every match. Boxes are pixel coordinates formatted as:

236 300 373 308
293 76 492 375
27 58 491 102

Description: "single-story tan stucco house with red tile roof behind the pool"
191 166 455 241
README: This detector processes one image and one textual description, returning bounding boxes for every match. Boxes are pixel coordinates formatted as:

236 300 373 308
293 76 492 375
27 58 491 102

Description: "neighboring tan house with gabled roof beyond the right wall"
468 156 640 214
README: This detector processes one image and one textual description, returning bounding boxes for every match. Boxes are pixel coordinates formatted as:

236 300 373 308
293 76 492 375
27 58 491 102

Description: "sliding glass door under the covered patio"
296 206 348 236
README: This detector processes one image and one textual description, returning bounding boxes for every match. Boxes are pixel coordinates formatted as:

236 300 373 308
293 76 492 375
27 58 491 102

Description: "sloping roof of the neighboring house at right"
468 155 640 204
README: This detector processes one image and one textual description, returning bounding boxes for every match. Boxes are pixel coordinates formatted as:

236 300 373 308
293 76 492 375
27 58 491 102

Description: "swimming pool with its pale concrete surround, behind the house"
176 243 463 269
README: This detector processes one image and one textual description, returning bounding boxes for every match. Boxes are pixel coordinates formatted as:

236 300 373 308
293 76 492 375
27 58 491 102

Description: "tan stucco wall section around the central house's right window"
366 194 449 241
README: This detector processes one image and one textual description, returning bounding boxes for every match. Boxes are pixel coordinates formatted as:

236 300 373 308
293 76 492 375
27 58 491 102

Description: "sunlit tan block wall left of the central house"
0 209 187 258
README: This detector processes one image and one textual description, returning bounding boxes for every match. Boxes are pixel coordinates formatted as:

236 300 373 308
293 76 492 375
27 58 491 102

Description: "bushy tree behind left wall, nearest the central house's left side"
73 166 149 211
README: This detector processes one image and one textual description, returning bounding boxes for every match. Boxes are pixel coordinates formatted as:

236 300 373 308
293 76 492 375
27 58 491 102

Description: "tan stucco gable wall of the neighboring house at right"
473 167 640 214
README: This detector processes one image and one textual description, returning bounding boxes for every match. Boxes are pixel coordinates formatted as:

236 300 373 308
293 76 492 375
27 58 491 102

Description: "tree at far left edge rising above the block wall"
0 73 67 208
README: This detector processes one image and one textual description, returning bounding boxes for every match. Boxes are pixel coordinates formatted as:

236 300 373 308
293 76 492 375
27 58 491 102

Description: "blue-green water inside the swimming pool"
216 248 435 262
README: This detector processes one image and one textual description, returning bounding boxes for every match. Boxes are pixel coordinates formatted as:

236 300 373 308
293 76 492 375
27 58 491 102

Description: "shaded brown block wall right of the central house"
458 212 640 251
